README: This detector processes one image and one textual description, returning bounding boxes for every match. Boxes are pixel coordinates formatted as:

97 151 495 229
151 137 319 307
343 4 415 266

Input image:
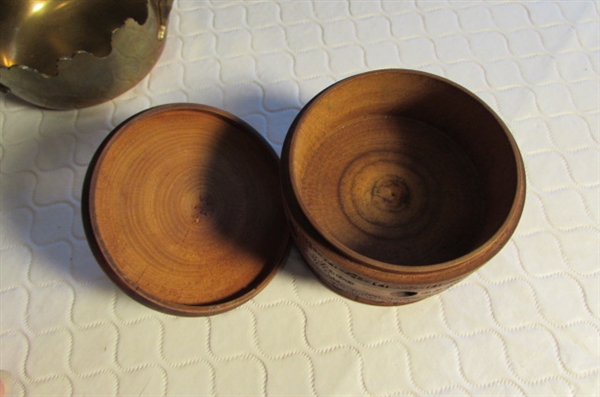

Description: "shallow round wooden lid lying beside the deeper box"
82 104 289 316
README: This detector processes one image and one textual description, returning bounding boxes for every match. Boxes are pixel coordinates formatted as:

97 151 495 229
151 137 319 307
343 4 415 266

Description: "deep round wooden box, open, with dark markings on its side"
282 70 525 305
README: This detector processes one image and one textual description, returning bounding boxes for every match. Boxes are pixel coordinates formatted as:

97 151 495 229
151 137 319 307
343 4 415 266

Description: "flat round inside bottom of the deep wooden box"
301 115 485 266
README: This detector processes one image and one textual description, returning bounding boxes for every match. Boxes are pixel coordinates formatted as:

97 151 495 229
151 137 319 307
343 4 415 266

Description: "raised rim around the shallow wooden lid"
81 103 290 317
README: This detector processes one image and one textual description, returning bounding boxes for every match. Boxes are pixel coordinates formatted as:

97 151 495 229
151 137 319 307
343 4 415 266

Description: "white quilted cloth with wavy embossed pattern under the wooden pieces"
0 0 600 396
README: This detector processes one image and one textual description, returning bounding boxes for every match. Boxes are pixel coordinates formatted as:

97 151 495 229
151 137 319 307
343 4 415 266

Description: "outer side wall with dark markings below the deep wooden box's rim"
292 220 460 305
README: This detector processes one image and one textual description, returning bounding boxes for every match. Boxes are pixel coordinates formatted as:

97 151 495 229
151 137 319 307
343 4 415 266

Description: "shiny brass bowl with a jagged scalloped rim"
0 0 173 109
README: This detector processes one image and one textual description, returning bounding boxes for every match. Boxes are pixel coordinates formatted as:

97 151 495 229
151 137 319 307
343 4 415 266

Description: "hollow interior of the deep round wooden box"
290 71 517 266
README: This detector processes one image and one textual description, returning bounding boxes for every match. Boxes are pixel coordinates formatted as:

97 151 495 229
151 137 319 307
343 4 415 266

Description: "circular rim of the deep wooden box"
282 69 526 273
